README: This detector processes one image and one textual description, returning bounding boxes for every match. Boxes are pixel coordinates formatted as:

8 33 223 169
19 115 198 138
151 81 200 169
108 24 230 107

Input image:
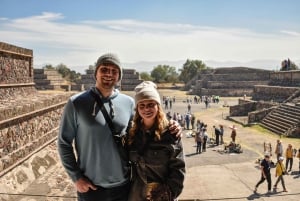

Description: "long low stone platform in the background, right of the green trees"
189 67 270 96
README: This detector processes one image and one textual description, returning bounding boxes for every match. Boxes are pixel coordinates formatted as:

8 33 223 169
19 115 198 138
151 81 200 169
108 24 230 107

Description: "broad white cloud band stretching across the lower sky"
0 12 300 70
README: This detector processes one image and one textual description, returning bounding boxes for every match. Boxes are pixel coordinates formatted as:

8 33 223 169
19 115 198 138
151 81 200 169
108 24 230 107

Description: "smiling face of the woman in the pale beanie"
137 100 158 120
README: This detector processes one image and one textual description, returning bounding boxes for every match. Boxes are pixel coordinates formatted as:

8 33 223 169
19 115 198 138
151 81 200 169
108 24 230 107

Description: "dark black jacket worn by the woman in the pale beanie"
129 130 185 201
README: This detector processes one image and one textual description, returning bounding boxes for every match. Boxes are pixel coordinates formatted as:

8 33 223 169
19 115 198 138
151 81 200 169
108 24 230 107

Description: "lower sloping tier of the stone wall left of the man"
0 94 71 175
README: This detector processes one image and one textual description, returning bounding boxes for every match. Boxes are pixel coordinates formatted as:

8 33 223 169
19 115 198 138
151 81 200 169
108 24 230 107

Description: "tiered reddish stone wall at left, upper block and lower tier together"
0 42 72 177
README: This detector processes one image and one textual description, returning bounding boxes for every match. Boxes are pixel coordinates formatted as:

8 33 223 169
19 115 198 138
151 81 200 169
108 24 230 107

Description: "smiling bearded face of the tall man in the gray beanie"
96 64 120 89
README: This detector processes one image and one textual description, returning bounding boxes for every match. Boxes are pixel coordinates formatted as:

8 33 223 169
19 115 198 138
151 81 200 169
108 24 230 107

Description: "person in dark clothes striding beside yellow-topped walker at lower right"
254 153 272 193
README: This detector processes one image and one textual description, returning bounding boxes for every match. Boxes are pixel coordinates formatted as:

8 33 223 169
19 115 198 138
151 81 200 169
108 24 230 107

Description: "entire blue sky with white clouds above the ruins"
0 0 300 70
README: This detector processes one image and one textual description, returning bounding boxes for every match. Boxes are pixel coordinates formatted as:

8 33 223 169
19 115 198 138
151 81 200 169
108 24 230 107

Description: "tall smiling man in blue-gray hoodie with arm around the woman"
58 53 181 201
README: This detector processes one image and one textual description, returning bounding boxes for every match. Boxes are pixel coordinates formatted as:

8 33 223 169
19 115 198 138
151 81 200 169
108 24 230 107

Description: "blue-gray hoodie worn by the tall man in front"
58 87 135 188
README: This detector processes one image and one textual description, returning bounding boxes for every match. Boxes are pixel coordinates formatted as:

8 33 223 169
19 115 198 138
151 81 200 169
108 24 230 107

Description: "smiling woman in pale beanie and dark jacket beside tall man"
128 81 185 201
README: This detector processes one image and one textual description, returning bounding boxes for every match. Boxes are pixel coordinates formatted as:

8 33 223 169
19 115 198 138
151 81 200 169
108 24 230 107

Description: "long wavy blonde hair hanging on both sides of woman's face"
128 104 169 144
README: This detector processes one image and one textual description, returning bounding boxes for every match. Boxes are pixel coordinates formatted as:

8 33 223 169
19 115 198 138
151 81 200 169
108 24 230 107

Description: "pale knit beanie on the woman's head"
134 81 161 104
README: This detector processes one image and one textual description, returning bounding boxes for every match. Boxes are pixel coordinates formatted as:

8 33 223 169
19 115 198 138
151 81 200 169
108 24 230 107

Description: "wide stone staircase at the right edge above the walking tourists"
260 103 300 136
